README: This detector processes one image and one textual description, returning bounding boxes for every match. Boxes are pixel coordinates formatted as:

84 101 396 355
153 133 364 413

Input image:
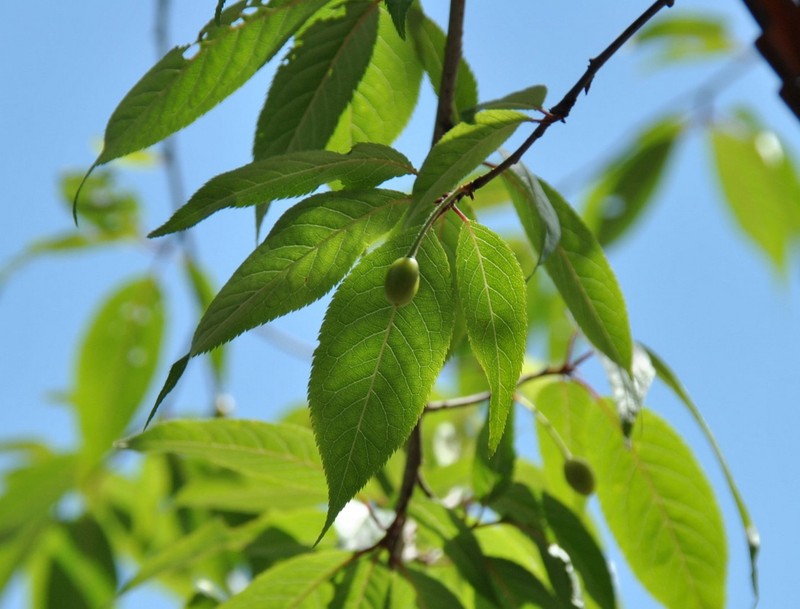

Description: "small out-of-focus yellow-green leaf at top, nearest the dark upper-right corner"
633 12 736 64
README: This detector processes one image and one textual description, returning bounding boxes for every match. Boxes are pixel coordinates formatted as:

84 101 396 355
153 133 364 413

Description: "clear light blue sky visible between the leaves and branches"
0 0 800 609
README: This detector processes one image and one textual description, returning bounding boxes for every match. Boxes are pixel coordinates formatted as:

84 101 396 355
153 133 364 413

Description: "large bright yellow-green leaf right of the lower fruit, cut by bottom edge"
589 403 727 609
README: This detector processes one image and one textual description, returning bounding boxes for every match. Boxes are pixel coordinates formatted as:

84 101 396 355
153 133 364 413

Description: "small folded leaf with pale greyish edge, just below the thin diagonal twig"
496 163 561 267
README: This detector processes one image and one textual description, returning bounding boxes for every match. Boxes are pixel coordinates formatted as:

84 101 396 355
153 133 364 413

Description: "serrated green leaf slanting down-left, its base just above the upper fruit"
191 190 408 355
